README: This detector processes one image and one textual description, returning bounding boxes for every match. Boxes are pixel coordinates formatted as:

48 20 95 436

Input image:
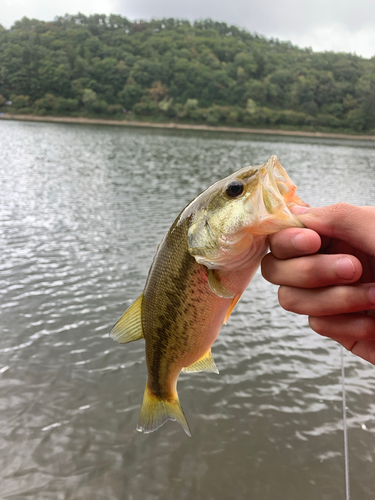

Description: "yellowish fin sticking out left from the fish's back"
110 293 144 344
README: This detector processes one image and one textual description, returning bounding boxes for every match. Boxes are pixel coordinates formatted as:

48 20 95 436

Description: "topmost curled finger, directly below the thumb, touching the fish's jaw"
270 227 321 260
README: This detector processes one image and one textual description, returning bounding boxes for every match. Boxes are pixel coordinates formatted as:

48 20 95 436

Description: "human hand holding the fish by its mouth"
262 203 375 364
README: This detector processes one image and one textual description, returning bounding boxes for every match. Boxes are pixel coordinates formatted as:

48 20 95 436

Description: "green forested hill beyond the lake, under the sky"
0 14 375 133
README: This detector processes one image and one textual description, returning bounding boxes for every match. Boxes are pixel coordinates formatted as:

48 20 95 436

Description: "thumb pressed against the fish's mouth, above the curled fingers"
291 203 375 256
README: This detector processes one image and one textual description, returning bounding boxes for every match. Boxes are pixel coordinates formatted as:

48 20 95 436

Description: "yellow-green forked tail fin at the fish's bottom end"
137 384 191 437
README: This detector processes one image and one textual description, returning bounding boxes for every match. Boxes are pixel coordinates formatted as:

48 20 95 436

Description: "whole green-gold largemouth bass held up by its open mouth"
110 156 308 436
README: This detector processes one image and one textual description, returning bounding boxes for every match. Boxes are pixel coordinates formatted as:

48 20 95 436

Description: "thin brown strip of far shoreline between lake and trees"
0 113 375 141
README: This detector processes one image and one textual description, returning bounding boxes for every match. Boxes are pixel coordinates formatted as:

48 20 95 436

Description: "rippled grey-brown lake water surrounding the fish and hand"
0 121 375 500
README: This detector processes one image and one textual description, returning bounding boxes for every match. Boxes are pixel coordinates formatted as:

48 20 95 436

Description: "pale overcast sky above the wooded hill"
0 0 375 57
